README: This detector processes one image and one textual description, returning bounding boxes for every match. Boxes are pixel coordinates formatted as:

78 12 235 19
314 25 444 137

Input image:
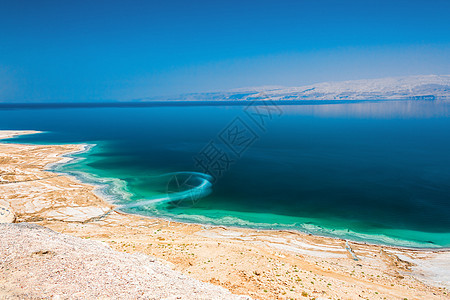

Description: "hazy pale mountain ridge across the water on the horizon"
140 75 450 101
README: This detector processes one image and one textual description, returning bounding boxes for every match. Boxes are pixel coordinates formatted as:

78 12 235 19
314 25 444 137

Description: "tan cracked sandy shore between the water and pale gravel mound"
0 131 450 299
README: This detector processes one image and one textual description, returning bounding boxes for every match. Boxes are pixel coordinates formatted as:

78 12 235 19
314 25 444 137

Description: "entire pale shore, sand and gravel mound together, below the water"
0 131 450 299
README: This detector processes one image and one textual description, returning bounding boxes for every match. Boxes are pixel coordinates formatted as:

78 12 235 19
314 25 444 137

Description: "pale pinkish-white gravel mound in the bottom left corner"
0 223 246 299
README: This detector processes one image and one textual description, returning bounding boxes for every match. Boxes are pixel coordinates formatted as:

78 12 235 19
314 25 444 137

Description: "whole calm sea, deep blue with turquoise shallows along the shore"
0 101 450 247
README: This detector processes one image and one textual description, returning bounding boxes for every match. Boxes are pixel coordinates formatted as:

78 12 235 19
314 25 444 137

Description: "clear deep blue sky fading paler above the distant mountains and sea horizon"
0 0 450 102
